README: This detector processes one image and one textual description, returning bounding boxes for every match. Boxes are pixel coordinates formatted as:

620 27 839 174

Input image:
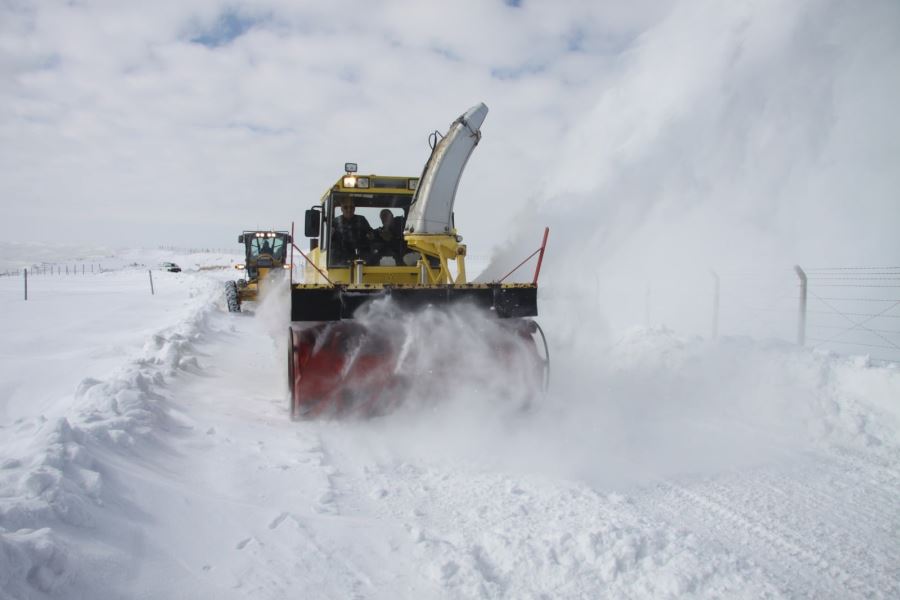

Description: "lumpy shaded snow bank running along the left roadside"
0 260 221 598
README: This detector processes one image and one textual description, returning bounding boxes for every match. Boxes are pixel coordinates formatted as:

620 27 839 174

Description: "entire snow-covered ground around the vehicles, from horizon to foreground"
0 251 900 600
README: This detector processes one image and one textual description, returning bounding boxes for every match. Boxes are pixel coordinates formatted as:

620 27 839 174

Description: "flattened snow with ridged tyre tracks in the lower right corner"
639 452 900 598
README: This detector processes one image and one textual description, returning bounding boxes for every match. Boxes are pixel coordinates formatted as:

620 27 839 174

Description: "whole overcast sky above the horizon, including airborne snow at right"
0 0 900 278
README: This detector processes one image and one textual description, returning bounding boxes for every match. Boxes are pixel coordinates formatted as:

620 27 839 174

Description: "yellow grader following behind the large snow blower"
225 231 293 312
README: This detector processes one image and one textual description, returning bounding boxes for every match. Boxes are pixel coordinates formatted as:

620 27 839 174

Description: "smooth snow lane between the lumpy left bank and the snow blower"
158 304 408 600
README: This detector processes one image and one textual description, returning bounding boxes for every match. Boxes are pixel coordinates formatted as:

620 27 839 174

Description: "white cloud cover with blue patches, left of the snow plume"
0 0 656 246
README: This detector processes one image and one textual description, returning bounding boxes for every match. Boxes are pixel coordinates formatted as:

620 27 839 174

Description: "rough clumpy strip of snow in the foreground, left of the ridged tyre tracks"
312 438 774 598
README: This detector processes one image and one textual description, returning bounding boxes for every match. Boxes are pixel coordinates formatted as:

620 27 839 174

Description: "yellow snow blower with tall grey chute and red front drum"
288 104 549 419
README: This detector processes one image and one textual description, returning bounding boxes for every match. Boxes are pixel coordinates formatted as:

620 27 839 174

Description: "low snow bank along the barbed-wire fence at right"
608 329 900 448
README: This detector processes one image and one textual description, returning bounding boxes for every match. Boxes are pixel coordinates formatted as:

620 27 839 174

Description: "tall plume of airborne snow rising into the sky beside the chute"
482 1 900 333
